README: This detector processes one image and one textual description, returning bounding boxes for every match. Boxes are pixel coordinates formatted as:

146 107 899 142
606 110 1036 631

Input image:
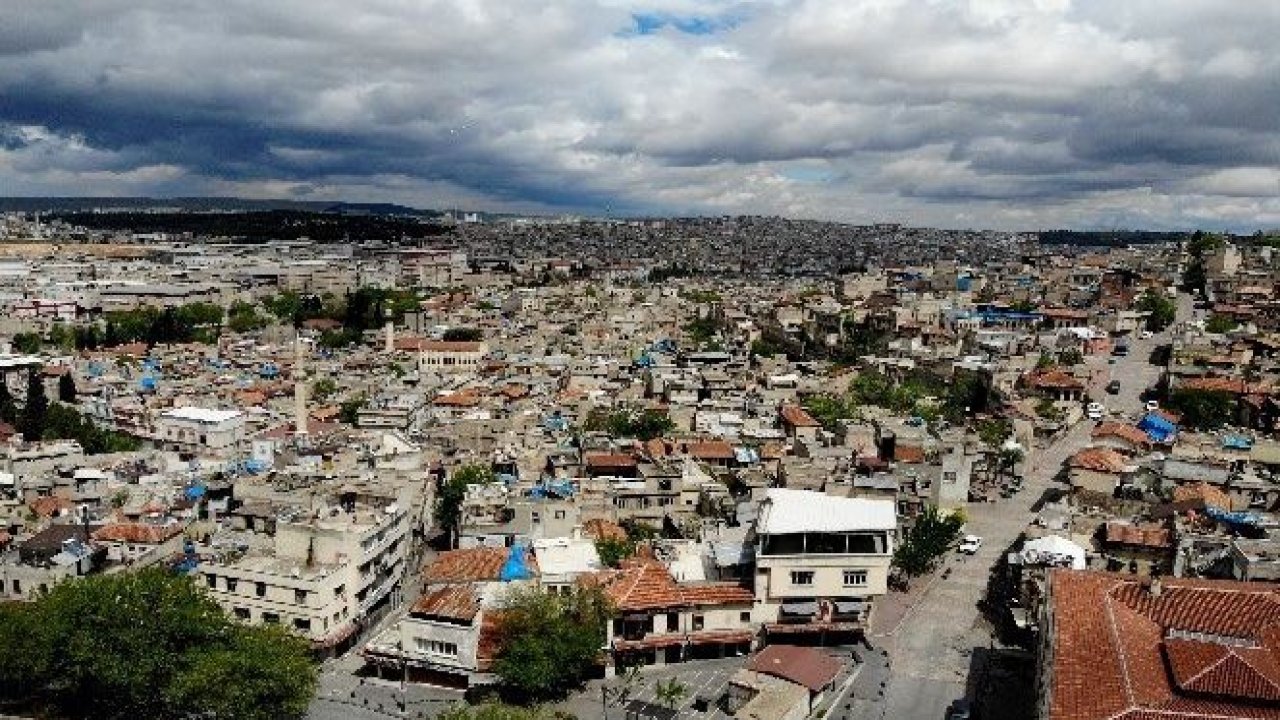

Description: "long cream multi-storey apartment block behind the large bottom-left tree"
200 491 410 650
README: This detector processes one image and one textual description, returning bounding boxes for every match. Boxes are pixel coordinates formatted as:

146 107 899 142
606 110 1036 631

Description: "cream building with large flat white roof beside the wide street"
753 488 897 638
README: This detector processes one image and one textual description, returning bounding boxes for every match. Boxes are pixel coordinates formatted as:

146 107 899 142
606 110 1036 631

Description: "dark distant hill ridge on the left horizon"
0 197 444 218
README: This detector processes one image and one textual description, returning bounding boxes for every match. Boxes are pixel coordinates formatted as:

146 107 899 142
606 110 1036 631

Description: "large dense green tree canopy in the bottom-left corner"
0 569 316 720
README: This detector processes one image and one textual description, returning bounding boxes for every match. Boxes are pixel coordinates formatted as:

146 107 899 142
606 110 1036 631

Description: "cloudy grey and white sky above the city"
0 0 1280 232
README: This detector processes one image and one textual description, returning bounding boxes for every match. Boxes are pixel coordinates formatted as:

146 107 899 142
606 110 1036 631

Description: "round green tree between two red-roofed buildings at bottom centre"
493 585 613 702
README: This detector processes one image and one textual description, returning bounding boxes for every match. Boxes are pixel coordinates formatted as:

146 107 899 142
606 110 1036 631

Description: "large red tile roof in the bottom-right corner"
1046 570 1280 720
